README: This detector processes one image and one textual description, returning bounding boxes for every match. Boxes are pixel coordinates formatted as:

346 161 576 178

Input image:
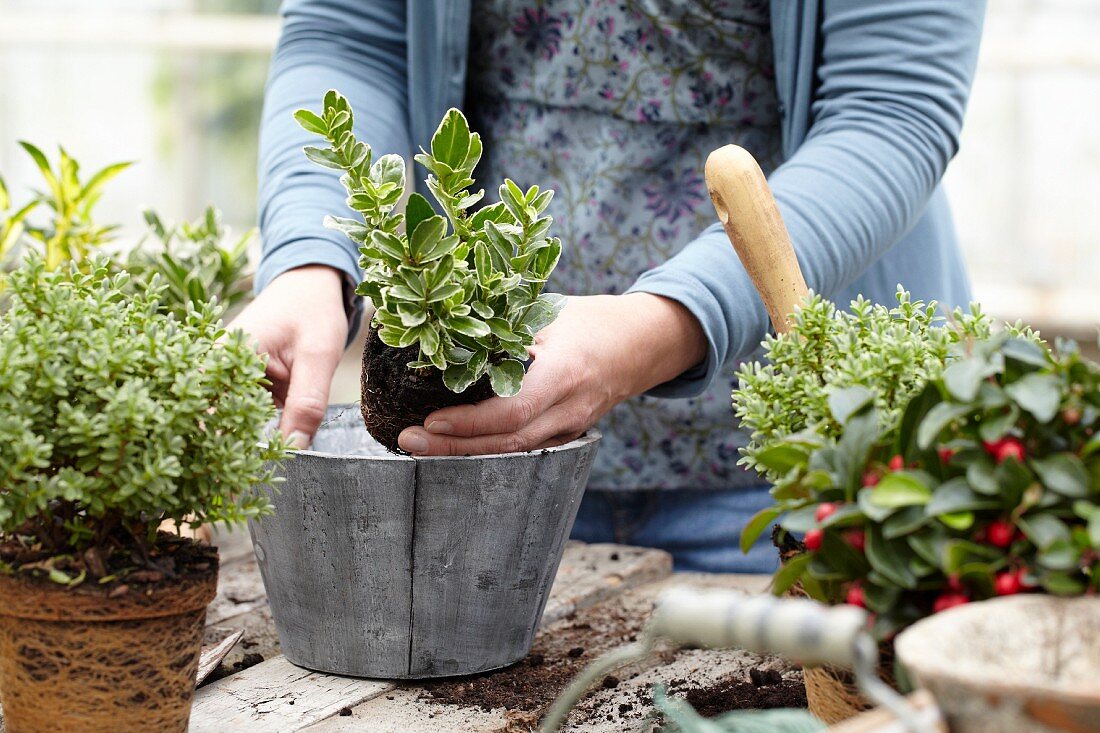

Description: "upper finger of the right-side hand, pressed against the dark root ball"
424 362 568 438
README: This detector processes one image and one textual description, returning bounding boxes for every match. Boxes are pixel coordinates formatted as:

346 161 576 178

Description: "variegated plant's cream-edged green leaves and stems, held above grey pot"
295 90 562 396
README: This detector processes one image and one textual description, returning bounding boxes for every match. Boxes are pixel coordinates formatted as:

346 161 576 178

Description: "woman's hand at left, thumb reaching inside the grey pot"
229 265 348 448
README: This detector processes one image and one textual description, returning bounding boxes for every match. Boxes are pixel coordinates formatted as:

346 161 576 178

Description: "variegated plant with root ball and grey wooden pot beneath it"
243 91 600 678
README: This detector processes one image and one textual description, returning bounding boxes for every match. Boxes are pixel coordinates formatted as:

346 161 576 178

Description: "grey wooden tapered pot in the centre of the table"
250 405 600 679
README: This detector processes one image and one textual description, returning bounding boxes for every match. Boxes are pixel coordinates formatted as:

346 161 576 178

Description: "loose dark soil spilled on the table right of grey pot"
421 600 806 724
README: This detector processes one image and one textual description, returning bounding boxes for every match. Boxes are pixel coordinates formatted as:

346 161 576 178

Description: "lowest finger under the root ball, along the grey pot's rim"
397 406 584 456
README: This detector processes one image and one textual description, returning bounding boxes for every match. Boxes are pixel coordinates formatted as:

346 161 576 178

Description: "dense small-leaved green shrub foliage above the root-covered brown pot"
0 255 285 576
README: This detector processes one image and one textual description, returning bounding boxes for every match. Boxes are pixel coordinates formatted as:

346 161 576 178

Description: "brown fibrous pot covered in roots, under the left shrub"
0 556 218 733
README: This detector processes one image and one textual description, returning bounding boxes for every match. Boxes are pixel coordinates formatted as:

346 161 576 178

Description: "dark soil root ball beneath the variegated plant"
360 324 493 452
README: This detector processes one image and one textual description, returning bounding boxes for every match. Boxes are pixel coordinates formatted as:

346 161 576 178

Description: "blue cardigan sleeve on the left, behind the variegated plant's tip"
255 0 410 336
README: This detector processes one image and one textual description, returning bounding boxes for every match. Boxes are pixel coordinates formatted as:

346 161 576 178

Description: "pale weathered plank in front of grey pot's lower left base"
190 657 394 733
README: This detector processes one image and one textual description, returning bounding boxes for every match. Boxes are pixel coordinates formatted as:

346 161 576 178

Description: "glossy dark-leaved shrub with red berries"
747 329 1100 638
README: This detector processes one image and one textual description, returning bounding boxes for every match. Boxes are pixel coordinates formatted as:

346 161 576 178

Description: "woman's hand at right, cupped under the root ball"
398 293 706 456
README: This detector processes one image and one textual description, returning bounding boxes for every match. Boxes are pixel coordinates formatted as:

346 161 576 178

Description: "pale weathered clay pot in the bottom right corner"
895 594 1100 733
